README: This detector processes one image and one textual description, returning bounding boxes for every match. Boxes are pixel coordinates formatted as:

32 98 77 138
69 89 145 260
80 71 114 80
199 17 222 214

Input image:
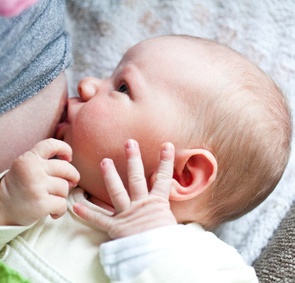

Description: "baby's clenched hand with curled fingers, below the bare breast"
0 139 80 225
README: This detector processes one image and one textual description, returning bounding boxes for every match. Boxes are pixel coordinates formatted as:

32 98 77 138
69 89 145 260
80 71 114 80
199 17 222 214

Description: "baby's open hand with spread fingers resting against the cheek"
74 140 177 239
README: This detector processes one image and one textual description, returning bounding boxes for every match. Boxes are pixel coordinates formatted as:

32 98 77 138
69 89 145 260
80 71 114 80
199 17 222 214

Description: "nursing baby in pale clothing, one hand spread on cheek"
0 36 291 282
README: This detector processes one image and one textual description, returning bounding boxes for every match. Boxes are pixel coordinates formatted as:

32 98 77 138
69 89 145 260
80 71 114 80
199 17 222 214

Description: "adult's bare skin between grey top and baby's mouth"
0 73 67 172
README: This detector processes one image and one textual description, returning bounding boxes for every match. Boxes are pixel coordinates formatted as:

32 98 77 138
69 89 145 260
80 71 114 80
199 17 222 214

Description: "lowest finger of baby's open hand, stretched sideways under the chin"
73 202 112 232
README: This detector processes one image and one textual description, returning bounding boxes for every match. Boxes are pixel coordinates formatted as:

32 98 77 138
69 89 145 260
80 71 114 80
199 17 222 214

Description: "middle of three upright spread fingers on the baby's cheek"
125 139 148 200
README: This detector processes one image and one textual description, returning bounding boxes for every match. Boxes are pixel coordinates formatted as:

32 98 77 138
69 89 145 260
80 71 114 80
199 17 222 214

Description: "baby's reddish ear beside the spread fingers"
170 149 217 201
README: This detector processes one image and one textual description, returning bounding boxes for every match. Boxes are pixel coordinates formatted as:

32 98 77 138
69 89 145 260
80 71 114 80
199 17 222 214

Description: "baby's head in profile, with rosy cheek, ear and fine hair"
58 36 291 229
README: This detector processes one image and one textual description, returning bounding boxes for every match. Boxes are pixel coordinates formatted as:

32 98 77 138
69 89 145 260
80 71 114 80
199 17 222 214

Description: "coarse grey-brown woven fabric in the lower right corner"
254 202 295 283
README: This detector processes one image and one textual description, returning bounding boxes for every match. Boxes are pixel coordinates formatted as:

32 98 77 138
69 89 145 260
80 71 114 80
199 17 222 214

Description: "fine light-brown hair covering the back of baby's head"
177 36 292 229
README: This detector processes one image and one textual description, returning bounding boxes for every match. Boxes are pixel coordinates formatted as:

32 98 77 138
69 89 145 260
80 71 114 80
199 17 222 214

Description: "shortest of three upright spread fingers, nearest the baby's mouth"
100 158 130 213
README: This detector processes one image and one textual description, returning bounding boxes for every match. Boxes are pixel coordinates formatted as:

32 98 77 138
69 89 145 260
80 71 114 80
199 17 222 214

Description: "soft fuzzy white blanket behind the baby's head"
68 0 295 264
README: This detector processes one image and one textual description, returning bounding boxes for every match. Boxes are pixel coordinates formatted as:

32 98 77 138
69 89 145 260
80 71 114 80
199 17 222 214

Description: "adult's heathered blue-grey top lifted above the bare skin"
0 0 71 114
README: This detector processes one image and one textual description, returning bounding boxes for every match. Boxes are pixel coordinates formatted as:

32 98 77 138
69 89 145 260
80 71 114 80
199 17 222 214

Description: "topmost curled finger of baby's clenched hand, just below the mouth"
31 138 72 161
